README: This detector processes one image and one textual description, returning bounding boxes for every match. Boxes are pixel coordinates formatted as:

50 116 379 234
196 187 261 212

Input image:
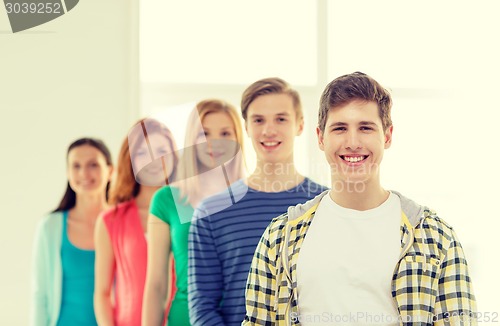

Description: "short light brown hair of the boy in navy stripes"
241 77 303 121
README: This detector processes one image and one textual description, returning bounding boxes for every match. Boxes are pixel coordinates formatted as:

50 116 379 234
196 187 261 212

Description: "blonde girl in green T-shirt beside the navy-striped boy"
142 100 243 326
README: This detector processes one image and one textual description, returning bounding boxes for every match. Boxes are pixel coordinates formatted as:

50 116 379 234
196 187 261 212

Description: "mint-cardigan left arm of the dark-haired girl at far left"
30 219 50 326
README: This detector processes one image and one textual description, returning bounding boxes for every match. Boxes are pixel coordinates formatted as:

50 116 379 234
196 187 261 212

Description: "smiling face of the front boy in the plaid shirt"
316 101 392 189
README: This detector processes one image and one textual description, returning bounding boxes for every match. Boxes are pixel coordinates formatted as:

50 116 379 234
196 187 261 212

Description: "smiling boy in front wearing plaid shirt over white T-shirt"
243 72 476 325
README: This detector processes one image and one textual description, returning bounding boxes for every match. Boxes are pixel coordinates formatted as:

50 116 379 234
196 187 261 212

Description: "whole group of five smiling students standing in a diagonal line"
31 72 477 326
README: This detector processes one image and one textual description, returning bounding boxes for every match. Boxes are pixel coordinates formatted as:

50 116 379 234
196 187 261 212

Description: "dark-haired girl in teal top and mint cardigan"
31 138 112 326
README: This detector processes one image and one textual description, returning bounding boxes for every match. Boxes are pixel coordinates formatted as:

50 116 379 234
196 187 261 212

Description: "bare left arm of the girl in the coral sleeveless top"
94 216 116 326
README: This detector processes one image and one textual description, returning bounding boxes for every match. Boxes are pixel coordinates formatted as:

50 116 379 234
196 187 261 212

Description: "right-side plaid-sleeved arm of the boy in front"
434 229 477 326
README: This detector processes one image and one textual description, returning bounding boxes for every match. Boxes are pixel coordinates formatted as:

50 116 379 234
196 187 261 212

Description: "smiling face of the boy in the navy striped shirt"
245 94 304 163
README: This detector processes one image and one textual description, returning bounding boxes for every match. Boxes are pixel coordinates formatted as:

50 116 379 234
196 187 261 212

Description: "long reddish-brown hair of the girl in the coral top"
109 118 179 205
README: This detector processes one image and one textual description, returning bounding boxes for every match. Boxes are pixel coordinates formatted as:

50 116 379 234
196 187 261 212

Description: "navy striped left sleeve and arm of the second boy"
188 212 224 326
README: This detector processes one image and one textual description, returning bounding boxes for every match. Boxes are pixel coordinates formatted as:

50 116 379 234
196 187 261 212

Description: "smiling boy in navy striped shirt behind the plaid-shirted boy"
188 78 325 326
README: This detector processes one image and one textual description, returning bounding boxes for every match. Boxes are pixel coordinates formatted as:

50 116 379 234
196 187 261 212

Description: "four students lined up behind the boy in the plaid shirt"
31 78 325 326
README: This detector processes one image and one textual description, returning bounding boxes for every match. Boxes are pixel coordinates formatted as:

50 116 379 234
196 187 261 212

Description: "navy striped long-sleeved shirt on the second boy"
188 178 326 326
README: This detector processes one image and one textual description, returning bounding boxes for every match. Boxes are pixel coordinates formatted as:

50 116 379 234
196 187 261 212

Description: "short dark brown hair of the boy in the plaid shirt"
318 71 392 132
